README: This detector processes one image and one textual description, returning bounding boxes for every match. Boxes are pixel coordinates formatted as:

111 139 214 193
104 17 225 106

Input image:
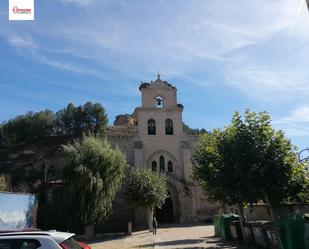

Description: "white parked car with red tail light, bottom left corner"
0 230 91 249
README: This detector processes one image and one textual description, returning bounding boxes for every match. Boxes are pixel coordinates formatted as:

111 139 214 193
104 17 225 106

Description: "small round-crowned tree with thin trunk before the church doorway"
126 168 167 231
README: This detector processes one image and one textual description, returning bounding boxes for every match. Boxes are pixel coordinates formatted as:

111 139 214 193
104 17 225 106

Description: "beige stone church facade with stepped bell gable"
107 75 217 228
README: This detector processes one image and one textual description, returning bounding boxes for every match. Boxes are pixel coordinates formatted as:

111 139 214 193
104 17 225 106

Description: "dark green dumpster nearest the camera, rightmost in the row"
277 214 306 249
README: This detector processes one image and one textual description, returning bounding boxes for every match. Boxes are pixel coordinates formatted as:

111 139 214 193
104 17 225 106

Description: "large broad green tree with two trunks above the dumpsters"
193 111 305 241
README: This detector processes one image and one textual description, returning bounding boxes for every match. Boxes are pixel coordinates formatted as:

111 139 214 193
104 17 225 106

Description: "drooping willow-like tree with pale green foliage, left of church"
60 136 126 231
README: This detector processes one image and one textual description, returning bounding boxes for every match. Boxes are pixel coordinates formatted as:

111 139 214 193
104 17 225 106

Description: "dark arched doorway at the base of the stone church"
155 191 175 224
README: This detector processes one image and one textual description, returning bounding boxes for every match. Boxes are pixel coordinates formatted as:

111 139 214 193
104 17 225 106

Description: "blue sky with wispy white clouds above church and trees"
0 0 309 149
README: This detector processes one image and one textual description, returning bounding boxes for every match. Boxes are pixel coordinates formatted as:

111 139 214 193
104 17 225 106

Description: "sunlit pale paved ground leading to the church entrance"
90 225 248 249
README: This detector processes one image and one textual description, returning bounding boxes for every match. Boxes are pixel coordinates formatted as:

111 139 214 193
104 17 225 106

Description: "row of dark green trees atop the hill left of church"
0 102 108 146
